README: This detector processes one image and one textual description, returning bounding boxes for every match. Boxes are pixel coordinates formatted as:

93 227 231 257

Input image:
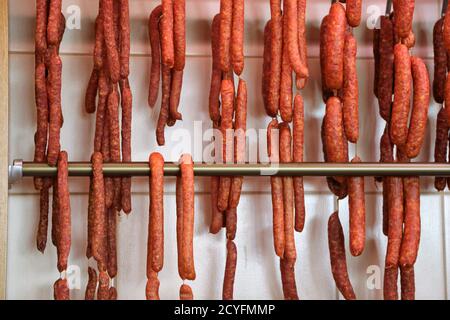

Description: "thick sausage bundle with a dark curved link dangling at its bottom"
320 0 365 299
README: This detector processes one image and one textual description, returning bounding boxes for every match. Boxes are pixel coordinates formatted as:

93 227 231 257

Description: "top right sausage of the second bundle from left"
119 0 130 79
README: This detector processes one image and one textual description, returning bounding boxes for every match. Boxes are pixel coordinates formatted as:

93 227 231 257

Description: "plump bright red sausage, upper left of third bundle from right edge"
324 2 347 90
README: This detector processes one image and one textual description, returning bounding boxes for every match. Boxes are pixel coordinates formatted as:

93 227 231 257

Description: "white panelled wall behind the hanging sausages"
7 0 450 299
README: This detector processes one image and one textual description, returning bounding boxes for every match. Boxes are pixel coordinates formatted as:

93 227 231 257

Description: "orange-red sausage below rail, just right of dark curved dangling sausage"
348 156 366 257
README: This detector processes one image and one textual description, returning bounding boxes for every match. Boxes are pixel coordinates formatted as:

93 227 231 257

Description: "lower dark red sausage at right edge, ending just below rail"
434 107 449 191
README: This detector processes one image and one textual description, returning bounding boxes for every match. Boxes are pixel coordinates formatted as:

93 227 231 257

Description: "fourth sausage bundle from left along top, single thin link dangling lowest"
209 0 247 300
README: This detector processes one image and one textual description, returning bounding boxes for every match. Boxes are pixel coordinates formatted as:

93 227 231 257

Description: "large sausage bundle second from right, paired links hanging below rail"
374 0 428 300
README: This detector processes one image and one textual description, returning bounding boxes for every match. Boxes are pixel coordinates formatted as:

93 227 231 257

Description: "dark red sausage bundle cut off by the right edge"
433 8 450 191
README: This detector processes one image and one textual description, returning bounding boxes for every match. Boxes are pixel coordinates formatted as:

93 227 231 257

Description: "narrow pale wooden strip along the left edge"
0 1 8 300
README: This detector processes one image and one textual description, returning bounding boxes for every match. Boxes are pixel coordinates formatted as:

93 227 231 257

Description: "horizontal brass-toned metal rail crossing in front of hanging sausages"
17 162 450 177
